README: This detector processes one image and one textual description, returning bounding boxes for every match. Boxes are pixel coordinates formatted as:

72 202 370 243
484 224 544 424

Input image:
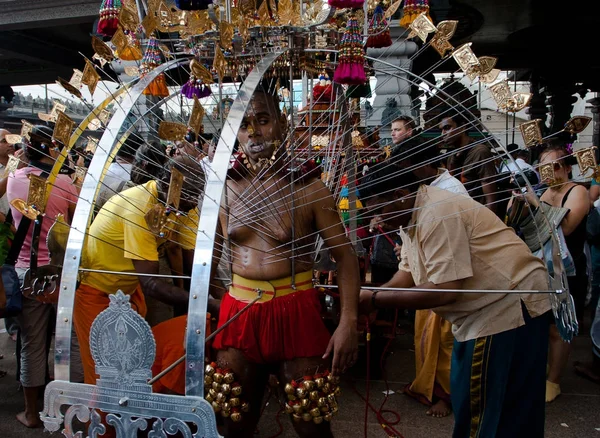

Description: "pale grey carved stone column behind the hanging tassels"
367 20 418 145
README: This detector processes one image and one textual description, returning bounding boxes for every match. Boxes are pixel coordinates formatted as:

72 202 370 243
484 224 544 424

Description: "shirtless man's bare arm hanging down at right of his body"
307 180 360 374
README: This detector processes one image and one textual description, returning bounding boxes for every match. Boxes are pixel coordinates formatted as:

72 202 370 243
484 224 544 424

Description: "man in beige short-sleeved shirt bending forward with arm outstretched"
360 148 550 438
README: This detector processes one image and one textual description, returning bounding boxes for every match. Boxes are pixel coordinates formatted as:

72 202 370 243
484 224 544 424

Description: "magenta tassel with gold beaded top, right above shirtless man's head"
333 15 367 85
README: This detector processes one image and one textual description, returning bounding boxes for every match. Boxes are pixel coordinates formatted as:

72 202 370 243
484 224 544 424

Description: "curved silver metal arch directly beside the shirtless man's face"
185 52 284 397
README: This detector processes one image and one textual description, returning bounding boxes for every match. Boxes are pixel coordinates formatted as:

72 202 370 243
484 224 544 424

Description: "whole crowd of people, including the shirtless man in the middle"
0 85 600 438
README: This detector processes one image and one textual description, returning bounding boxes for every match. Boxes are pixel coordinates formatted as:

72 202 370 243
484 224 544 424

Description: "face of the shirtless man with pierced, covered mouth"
237 93 285 161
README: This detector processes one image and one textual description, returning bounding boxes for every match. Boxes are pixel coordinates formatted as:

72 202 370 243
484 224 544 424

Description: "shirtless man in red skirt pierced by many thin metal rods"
213 90 360 437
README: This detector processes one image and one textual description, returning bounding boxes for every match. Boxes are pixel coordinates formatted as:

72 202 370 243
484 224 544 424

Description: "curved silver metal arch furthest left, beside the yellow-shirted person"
54 59 188 381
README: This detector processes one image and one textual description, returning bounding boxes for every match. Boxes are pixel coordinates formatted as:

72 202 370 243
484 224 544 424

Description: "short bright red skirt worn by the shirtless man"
213 289 331 364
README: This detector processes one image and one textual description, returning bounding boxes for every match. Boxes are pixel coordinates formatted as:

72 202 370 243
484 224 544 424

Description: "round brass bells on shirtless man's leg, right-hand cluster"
285 372 341 424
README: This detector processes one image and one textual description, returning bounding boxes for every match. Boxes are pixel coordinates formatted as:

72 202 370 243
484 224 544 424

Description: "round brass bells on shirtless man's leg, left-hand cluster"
204 362 250 423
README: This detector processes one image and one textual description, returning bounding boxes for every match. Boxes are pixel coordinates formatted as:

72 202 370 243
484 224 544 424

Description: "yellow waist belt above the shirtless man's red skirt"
229 271 313 303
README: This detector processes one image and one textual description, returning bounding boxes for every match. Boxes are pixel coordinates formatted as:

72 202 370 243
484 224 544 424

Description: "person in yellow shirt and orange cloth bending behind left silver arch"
73 156 204 384
